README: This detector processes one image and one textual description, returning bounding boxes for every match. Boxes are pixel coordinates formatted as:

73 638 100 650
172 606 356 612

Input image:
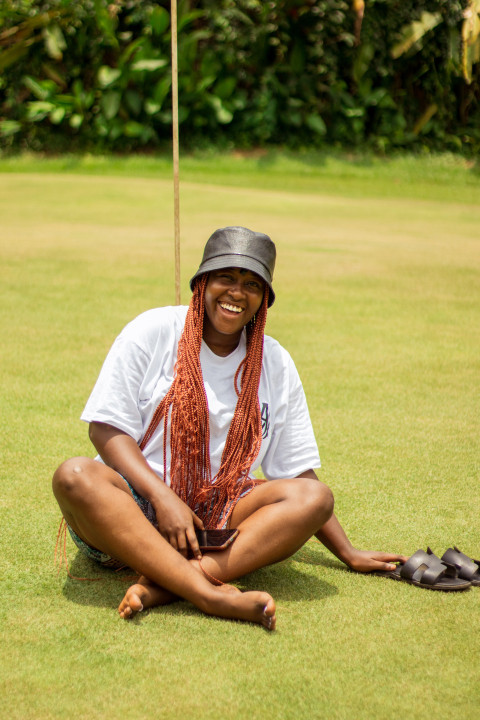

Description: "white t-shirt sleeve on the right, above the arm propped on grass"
262 351 320 480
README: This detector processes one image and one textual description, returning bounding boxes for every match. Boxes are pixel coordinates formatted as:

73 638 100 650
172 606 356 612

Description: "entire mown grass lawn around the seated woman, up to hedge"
0 154 480 720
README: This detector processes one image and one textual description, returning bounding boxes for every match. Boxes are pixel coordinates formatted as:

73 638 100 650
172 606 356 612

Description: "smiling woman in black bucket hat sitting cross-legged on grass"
53 227 405 630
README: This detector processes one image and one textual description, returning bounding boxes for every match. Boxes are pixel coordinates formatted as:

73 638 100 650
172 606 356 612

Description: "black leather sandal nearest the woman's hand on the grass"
372 548 472 591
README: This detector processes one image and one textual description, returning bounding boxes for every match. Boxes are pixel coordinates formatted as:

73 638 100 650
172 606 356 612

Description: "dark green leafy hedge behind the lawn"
0 0 480 154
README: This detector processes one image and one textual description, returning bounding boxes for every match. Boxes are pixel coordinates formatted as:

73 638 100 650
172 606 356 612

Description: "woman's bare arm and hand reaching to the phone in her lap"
89 422 203 558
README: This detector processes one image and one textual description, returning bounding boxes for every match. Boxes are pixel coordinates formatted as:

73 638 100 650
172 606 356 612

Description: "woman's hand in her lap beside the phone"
152 490 204 560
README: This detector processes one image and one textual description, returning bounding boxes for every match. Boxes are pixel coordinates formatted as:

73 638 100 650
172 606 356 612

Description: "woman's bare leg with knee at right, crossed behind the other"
120 478 333 616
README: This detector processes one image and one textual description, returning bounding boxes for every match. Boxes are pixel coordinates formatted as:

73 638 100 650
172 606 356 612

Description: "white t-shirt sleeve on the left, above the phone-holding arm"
81 324 149 442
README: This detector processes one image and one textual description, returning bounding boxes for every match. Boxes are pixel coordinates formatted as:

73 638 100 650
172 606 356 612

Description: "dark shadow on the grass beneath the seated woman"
62 546 341 614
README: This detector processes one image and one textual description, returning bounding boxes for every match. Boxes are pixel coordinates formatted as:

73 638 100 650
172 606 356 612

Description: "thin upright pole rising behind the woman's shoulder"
170 0 180 305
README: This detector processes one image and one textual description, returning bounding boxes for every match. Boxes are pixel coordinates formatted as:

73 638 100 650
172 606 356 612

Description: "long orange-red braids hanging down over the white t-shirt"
140 274 268 528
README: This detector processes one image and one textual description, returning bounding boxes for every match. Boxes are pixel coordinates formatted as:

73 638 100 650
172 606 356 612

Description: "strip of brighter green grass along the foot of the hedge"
0 150 480 203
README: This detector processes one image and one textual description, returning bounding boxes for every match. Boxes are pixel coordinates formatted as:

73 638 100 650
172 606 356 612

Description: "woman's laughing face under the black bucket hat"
204 268 265 344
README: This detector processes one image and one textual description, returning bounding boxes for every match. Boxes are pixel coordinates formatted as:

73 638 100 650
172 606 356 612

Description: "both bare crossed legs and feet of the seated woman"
53 458 333 629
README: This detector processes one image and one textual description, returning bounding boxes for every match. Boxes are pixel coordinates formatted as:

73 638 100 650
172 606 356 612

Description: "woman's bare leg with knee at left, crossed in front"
53 458 275 629
